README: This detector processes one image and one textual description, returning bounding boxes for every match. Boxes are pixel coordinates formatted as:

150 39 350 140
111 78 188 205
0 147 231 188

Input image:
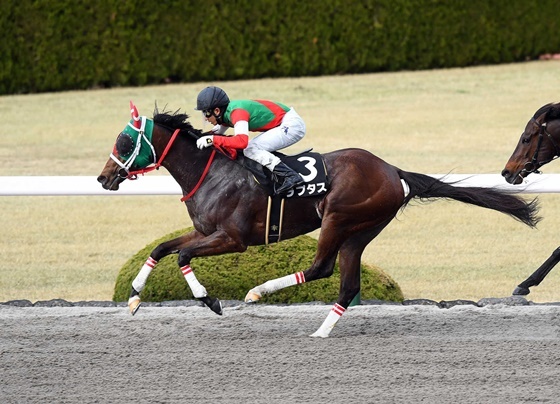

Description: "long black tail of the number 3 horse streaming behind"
399 170 541 227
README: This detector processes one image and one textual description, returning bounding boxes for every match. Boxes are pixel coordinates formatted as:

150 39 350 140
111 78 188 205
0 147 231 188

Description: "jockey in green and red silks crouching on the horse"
195 86 305 195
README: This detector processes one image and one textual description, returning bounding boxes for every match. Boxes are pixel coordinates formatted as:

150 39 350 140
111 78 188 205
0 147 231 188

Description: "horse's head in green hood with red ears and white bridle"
97 102 156 191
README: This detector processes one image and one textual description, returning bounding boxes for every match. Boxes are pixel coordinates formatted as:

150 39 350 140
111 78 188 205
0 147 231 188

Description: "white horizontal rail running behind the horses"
0 174 560 196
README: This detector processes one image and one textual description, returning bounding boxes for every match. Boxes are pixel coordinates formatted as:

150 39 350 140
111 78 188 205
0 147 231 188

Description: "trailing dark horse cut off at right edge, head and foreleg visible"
502 103 560 296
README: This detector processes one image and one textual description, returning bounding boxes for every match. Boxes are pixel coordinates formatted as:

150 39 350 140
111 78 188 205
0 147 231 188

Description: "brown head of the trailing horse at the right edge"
502 104 560 184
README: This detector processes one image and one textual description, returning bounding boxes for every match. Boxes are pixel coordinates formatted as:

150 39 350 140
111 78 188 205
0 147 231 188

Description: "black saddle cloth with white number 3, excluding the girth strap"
237 149 329 199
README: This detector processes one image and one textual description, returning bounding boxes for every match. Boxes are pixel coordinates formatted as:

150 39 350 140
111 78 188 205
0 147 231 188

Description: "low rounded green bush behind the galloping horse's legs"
113 228 403 303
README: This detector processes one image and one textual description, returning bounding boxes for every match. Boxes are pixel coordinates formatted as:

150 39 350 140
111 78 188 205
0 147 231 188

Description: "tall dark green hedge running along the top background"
0 0 560 94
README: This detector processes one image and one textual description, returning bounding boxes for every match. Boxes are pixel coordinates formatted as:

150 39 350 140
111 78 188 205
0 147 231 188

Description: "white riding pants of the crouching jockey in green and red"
243 108 305 171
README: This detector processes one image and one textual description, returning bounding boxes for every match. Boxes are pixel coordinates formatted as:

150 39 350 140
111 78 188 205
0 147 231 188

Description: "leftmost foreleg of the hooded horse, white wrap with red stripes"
128 231 208 315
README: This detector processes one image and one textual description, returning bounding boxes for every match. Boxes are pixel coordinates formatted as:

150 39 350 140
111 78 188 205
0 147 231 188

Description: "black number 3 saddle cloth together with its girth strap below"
238 150 329 244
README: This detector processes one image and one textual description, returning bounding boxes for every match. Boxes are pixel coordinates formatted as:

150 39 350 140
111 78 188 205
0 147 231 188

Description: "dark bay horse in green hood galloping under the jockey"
97 103 538 337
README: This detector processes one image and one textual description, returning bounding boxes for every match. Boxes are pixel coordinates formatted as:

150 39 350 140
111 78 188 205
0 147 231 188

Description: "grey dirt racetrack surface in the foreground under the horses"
0 298 560 404
